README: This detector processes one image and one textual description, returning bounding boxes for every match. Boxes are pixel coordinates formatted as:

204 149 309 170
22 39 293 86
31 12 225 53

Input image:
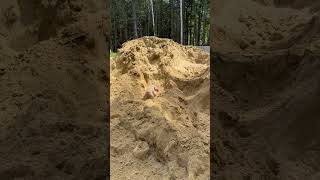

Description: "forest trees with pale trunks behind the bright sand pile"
111 0 210 51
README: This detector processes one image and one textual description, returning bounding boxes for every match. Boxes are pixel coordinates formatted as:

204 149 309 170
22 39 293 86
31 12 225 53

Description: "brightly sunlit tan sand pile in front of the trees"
110 37 210 179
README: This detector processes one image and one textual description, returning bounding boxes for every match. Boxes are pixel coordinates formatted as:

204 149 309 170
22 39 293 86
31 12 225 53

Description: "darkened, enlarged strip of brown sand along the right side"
211 0 320 180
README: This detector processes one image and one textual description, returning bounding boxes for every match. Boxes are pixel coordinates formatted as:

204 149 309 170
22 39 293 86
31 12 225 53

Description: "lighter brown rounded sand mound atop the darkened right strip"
212 0 316 53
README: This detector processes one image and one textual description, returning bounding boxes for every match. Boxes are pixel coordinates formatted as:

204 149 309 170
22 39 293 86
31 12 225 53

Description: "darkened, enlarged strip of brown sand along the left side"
0 0 108 180
